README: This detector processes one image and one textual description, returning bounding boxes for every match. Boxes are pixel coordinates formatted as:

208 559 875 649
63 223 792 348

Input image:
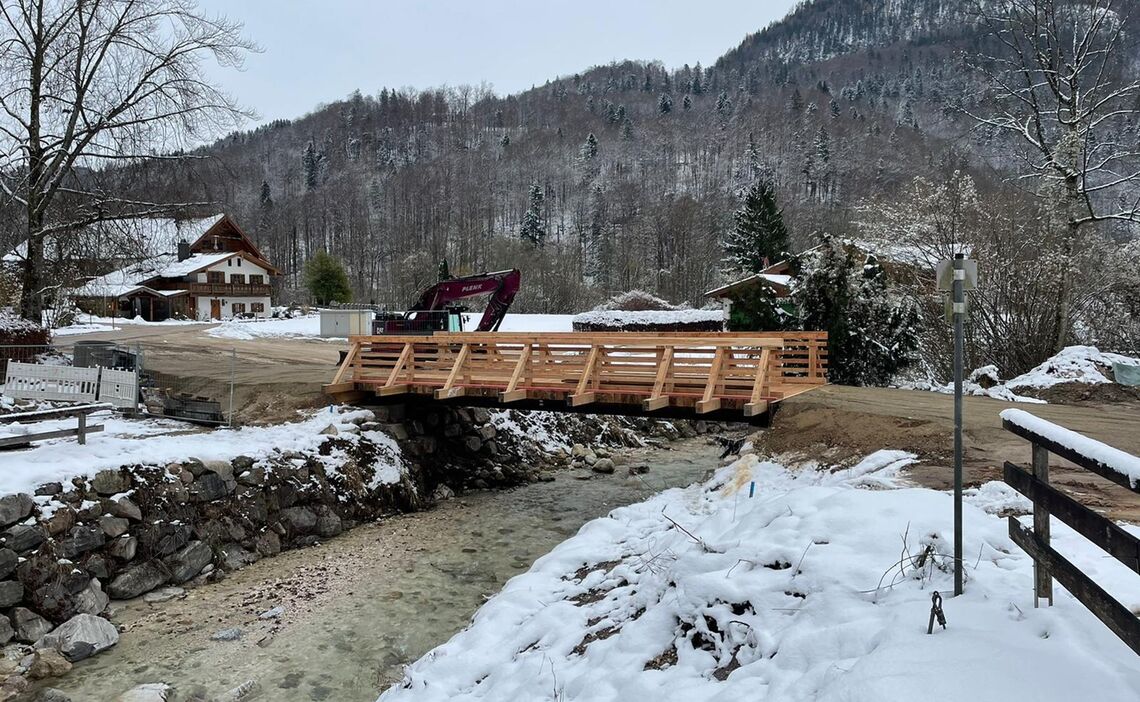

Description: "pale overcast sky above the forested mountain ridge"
200 0 795 122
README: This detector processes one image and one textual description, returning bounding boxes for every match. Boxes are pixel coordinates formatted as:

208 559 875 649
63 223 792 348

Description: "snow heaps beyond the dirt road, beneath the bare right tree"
898 346 1140 405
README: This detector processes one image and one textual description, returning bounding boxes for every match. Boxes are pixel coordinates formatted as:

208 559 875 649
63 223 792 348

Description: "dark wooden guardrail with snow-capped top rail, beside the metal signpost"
1001 409 1140 654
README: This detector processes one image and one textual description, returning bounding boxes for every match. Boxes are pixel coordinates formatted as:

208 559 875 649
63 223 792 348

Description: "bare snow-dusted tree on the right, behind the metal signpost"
968 0 1140 350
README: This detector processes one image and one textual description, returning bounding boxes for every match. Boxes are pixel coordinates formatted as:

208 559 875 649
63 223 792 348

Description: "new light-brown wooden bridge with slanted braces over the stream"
325 332 828 422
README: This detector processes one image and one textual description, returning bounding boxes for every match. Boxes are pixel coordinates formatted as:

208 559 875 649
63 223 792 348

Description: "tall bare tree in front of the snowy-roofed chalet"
0 0 257 320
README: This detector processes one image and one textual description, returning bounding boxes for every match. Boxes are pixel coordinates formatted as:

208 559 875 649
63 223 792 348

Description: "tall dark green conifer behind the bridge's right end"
725 179 789 274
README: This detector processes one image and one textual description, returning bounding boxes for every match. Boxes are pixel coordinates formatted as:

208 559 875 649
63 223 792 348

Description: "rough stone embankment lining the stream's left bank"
0 406 711 701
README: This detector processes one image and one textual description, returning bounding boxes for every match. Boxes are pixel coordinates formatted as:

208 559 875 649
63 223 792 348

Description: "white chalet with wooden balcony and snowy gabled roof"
73 214 280 321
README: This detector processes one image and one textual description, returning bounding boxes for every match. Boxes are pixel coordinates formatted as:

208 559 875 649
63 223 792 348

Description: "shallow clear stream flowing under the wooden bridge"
51 436 722 702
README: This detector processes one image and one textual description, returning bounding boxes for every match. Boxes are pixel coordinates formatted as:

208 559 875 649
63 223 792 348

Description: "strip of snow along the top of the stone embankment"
0 408 389 495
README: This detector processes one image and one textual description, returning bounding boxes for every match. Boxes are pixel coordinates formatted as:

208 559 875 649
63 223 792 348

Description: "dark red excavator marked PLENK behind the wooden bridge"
373 268 522 335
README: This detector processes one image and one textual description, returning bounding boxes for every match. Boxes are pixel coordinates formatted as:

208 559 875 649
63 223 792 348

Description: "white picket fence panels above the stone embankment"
3 361 139 409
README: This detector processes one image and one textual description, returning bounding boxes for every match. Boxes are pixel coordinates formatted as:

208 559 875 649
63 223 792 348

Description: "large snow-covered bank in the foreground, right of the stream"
380 451 1140 702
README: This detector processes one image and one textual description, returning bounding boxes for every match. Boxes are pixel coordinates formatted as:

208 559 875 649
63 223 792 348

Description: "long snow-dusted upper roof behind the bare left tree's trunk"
3 214 226 263
